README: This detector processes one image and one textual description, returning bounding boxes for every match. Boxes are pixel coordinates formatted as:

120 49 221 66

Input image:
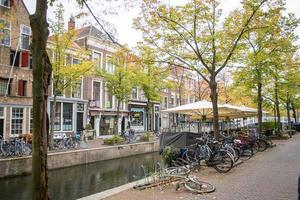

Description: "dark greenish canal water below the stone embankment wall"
0 152 161 200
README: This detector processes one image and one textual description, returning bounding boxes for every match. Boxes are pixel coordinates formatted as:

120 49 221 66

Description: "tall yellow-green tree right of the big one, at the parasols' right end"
234 1 296 132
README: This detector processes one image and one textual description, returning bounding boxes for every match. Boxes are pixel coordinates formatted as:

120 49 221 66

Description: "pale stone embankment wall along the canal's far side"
0 141 159 178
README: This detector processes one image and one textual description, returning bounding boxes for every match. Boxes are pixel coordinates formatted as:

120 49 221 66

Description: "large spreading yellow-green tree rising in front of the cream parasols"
134 0 267 137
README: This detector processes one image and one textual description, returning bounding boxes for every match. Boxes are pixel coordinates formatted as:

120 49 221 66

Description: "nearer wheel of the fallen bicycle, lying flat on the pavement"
184 176 216 194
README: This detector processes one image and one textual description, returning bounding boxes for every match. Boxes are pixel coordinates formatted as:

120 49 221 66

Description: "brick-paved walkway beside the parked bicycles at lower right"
106 133 300 200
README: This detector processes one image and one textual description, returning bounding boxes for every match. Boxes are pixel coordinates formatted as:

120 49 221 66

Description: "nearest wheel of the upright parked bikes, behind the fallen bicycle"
208 150 234 173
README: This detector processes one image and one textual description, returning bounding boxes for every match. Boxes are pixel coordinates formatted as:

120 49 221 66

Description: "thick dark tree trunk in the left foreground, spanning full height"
30 0 51 200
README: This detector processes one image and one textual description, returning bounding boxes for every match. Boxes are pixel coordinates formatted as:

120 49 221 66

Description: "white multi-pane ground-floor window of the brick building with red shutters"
11 108 24 134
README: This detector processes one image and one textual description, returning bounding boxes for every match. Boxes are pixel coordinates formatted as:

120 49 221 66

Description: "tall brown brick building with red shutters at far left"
0 0 32 139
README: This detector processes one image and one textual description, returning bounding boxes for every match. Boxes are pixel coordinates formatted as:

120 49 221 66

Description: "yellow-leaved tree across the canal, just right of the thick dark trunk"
48 3 94 150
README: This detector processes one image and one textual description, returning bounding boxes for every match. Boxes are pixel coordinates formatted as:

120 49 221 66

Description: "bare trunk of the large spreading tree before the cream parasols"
209 77 219 138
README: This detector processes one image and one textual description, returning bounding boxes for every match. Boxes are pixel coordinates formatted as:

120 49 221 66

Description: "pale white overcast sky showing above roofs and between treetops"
24 0 300 47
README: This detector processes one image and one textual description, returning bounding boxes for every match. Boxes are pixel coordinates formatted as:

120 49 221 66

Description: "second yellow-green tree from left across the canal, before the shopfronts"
98 48 138 134
